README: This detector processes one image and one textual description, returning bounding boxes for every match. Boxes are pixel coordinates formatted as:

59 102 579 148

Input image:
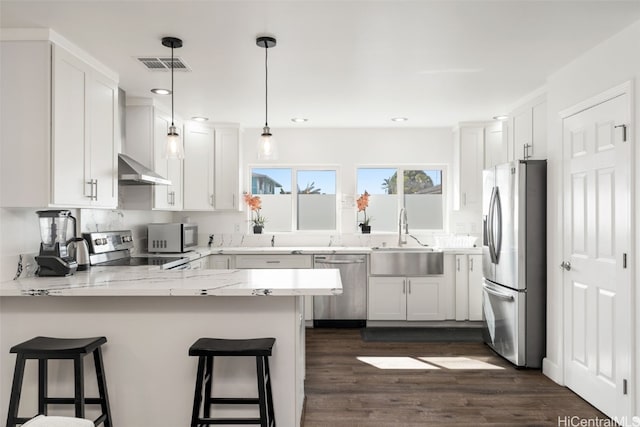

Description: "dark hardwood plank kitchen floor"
303 329 606 427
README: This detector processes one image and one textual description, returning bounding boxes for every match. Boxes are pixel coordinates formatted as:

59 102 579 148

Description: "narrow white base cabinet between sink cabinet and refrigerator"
455 254 482 320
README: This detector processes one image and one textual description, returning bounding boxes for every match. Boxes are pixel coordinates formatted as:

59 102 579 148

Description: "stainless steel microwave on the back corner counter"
147 222 198 252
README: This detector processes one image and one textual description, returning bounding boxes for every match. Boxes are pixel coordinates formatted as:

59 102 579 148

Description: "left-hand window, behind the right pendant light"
251 168 337 232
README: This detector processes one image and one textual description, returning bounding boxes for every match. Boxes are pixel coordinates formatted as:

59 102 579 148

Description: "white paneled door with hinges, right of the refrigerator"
562 87 633 417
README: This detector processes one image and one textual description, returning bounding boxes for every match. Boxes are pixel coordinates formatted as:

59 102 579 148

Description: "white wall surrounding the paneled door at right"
544 17 640 414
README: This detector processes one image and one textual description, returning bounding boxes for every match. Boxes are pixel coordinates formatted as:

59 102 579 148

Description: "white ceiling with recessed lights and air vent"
0 0 640 128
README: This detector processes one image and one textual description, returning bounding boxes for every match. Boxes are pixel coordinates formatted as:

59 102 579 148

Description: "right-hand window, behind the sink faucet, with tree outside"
357 168 444 231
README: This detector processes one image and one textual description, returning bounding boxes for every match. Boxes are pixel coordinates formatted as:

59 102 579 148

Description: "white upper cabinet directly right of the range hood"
120 97 184 211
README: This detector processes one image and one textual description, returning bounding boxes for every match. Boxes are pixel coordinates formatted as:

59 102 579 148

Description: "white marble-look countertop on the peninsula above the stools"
0 266 342 297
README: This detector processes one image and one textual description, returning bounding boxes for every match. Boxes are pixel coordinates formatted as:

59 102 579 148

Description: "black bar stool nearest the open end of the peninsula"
189 338 276 427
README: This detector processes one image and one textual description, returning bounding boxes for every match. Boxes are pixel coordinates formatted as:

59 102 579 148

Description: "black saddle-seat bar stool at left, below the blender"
7 337 111 427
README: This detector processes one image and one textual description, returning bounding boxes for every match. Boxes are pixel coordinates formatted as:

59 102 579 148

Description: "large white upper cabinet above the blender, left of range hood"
0 35 120 208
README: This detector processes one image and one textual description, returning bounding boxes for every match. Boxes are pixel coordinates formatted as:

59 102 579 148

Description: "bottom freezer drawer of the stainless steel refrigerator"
482 279 527 366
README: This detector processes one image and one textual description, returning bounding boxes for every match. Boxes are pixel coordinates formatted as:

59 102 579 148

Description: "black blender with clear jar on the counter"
36 210 78 276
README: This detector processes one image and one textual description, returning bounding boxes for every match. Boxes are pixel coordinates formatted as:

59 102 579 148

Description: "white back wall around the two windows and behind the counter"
184 128 460 245
